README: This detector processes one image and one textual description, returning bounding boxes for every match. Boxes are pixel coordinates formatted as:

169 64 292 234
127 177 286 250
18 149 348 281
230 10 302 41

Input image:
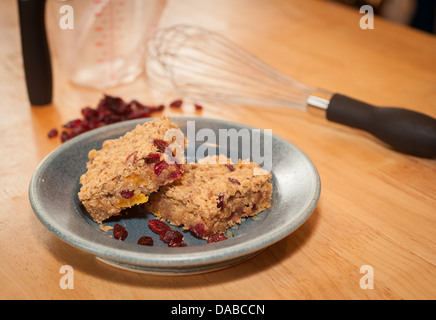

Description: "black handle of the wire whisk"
327 94 436 158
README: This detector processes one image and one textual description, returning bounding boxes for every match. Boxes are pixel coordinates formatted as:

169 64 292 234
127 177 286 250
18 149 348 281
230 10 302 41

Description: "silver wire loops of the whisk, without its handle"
146 25 312 110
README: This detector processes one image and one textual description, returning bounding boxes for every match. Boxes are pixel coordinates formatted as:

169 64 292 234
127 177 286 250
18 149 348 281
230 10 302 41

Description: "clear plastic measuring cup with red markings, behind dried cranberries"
46 0 166 89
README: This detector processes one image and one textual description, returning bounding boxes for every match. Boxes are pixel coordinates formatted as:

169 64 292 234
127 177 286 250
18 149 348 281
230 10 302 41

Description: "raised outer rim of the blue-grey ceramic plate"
28 116 321 269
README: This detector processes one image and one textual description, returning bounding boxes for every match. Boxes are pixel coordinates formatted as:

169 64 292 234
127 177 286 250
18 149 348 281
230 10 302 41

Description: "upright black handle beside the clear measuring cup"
18 0 53 106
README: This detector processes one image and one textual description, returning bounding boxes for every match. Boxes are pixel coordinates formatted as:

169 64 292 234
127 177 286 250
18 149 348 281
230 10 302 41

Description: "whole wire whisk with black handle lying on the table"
146 25 436 158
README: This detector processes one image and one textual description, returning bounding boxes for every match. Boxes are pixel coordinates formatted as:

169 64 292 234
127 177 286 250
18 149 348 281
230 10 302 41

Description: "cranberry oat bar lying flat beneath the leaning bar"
143 157 272 239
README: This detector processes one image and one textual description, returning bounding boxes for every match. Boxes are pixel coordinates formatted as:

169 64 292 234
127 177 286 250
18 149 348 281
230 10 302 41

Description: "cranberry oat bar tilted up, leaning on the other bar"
78 116 186 223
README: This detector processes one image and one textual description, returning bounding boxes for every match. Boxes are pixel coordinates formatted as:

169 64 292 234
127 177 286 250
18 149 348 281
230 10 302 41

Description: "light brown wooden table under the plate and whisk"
0 0 436 299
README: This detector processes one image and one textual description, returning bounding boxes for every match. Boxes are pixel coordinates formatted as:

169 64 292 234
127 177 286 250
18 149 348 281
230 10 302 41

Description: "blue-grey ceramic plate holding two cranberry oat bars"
29 117 320 275
